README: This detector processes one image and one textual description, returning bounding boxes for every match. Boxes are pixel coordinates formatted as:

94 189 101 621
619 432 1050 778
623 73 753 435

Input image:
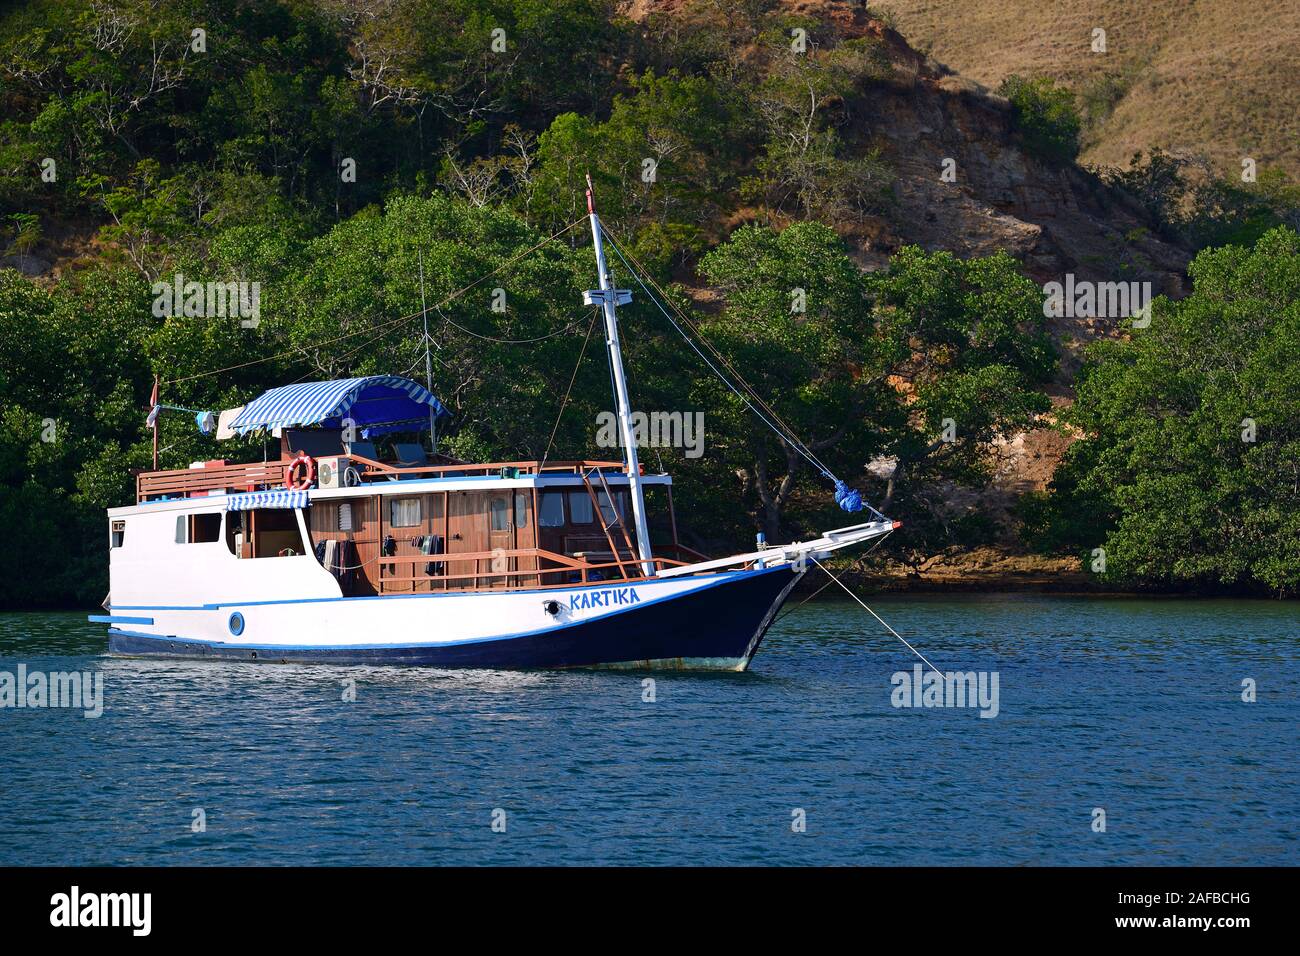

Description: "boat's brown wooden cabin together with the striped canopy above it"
137 376 703 596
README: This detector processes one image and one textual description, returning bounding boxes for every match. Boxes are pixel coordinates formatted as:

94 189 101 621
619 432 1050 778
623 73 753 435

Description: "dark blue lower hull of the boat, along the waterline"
108 567 798 670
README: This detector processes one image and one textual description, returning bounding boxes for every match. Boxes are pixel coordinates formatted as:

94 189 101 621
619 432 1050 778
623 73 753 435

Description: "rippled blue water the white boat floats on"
0 596 1300 865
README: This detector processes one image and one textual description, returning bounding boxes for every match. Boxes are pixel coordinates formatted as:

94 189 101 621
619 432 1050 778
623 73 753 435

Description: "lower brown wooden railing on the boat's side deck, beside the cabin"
377 548 686 594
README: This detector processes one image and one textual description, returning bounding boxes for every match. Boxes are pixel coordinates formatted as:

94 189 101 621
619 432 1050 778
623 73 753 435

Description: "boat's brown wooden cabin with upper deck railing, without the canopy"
137 436 703 596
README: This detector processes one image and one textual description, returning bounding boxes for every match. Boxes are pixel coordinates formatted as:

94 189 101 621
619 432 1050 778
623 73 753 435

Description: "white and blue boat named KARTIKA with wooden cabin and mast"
90 193 898 671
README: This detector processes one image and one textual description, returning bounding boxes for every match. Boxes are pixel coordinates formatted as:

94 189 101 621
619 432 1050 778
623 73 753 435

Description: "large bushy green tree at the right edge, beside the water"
1023 228 1300 594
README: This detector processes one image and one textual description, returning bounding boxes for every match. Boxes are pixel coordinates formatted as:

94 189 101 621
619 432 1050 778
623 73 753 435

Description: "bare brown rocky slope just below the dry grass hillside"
625 0 1191 356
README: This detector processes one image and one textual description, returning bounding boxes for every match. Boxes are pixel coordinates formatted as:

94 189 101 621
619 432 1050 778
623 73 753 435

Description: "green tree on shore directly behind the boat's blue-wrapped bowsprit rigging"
693 222 889 541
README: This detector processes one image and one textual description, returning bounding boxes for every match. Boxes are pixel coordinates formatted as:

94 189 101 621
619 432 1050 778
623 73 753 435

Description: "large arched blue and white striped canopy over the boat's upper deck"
230 375 450 434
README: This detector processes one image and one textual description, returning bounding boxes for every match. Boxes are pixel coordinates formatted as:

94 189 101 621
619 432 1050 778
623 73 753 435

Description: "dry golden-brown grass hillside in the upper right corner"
871 0 1300 178
